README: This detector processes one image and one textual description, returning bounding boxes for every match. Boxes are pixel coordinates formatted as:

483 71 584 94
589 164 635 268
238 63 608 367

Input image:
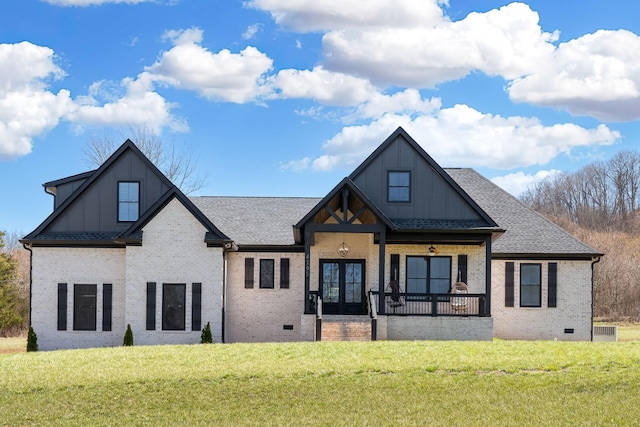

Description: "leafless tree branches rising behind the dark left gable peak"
84 126 206 194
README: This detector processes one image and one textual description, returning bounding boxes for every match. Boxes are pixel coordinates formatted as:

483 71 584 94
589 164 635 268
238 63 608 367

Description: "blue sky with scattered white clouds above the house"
0 0 640 233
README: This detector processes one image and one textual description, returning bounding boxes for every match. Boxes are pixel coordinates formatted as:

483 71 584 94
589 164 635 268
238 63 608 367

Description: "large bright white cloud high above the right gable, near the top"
322 3 556 88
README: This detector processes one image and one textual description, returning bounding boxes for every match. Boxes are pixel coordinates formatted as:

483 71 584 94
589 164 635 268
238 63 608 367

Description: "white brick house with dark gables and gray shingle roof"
22 128 601 349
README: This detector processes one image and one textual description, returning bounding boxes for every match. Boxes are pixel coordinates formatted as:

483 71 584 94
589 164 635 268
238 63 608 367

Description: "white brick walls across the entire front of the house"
32 211 591 350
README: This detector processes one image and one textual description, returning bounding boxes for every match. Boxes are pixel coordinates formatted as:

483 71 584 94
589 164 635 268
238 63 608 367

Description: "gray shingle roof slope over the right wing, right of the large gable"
445 168 598 255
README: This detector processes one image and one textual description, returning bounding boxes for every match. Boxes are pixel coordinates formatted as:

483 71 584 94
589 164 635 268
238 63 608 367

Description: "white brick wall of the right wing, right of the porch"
491 260 592 341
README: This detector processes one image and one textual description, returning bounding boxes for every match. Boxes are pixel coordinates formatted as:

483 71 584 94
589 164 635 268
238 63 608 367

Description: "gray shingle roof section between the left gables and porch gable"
190 196 322 245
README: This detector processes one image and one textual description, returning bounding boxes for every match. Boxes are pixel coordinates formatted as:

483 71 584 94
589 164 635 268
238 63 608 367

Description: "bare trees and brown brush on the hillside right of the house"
520 150 640 321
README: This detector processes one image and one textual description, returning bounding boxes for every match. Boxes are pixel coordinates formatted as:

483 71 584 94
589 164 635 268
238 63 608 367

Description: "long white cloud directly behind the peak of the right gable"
288 105 620 170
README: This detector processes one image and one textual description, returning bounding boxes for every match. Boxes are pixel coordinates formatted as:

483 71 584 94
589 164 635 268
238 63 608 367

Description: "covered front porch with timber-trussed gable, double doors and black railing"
294 178 499 339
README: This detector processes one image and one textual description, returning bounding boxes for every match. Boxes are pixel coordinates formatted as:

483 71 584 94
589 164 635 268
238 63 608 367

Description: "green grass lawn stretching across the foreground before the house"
0 340 640 426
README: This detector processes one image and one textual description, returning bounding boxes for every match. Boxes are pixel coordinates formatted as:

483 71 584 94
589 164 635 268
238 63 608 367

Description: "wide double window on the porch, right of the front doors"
407 256 451 300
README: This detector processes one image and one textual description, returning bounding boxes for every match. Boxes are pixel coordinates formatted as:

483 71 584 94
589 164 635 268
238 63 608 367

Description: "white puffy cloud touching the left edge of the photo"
0 42 73 160
